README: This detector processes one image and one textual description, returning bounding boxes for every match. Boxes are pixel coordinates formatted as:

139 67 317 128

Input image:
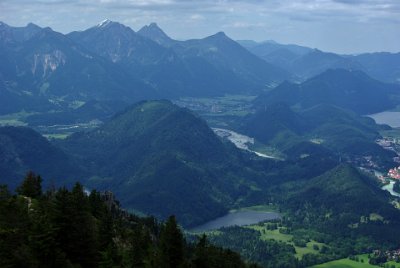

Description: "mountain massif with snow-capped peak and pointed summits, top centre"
68 21 289 98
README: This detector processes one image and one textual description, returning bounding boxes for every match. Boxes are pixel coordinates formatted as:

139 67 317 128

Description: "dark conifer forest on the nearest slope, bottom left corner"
0 172 256 268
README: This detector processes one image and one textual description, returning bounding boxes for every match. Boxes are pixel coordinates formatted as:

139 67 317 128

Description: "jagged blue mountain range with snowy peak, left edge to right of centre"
0 21 290 114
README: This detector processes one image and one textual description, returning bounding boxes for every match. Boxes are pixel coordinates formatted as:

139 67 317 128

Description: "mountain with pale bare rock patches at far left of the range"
0 21 154 112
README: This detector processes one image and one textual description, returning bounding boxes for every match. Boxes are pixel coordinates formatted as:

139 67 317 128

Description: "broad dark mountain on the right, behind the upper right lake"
255 69 400 114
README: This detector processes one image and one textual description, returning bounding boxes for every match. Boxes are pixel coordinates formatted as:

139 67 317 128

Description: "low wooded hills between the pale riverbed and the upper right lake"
238 103 396 170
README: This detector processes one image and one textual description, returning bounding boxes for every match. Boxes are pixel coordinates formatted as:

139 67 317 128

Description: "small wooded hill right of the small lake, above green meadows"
285 165 400 245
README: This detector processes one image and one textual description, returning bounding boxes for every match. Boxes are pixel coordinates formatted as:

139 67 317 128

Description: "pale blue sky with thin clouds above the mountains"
0 0 400 54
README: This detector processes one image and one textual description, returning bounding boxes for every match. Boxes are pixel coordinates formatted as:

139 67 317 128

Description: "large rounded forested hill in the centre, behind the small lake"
58 101 260 225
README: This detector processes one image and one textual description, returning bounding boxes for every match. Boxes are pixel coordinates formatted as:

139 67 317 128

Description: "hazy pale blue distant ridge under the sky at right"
238 40 400 84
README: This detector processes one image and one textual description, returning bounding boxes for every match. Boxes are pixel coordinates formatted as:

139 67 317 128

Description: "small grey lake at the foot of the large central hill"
190 211 280 232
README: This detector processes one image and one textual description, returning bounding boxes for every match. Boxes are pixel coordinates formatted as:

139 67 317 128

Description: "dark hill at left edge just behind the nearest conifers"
0 127 81 189
